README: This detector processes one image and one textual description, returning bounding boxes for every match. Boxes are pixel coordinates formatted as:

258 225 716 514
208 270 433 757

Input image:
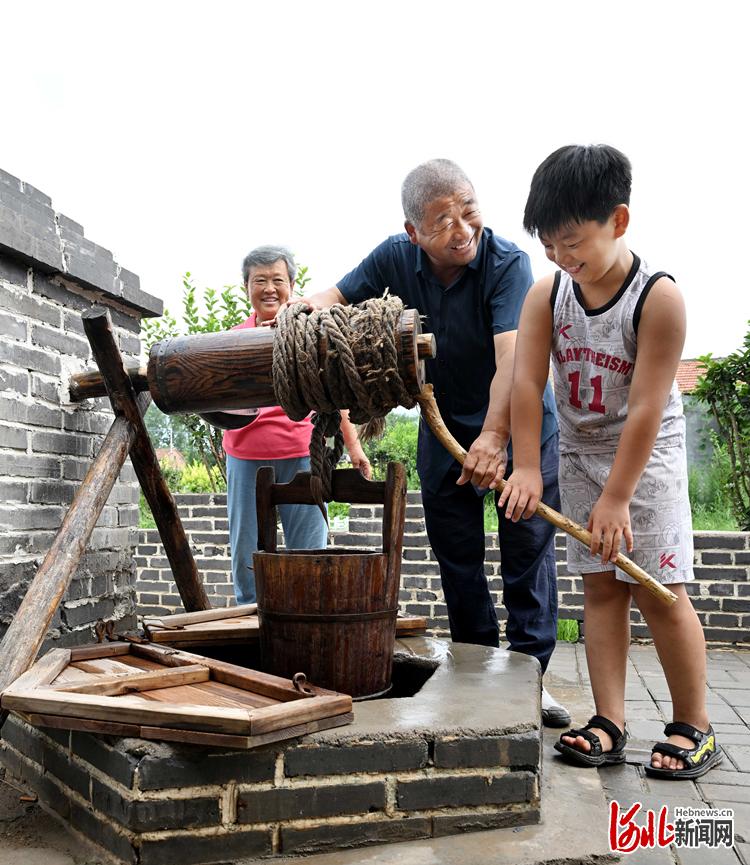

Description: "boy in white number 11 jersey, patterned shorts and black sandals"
499 145 722 779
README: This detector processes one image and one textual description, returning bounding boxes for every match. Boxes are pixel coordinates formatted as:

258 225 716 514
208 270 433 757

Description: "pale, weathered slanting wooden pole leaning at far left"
0 394 151 723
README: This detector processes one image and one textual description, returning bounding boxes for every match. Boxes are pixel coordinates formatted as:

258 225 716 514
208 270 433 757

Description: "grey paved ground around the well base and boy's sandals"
0 644 750 865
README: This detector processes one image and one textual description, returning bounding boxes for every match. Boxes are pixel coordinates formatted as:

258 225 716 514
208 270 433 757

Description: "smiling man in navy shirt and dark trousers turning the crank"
294 159 570 726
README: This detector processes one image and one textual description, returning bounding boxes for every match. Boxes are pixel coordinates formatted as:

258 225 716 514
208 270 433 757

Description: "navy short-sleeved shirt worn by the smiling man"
337 228 557 489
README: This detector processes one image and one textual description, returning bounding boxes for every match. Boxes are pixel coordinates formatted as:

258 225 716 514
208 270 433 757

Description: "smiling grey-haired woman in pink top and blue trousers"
225 246 370 604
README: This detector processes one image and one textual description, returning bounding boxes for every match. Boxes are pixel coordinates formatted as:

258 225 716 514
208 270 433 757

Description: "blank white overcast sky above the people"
0 0 750 357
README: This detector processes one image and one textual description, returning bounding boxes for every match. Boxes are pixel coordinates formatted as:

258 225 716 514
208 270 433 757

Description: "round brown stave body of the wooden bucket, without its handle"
255 550 398 699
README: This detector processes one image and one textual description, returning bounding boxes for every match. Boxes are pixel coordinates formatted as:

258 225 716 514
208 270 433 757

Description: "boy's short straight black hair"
523 144 631 237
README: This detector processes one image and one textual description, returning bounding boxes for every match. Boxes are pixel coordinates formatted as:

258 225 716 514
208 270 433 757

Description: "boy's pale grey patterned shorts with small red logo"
560 446 695 583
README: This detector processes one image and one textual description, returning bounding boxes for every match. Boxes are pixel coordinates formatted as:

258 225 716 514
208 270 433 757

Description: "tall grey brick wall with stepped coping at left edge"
0 170 162 648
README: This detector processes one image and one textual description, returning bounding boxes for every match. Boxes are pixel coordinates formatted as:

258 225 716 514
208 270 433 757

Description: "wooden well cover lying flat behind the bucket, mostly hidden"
143 604 427 648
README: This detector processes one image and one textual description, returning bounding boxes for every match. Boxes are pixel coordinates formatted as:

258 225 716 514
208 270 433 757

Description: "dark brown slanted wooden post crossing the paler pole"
81 308 211 613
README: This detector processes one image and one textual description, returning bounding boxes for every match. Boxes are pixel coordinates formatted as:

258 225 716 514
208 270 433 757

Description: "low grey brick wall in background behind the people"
136 492 750 644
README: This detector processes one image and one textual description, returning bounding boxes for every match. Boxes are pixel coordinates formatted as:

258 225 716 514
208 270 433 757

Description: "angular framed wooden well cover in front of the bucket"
0 642 353 748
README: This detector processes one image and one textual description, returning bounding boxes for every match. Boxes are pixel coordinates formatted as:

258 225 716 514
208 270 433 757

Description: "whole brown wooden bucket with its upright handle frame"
254 463 406 699
